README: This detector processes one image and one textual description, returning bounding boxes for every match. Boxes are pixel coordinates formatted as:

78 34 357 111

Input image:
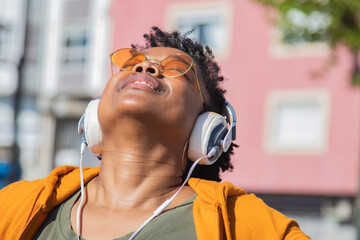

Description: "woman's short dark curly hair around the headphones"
132 26 238 182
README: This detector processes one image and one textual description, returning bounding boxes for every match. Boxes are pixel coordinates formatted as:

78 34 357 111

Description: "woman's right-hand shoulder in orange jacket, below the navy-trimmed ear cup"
189 179 310 239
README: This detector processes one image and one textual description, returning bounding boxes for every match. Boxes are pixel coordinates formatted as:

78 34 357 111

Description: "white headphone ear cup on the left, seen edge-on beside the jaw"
84 99 102 154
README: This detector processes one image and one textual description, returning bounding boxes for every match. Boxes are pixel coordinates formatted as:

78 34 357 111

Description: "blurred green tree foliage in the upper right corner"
255 0 360 85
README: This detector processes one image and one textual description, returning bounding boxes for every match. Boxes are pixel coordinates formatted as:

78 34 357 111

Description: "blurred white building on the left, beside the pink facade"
0 0 111 179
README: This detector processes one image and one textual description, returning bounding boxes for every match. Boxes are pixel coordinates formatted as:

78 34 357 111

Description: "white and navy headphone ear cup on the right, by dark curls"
188 112 227 165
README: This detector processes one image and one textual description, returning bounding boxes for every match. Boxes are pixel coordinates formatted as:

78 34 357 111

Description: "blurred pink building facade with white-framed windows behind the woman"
110 0 360 196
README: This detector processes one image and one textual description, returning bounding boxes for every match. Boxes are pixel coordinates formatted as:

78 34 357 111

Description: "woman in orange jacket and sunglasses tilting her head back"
0 27 309 239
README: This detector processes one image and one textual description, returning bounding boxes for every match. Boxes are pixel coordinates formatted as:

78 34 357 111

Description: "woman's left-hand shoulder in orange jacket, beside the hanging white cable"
0 166 99 239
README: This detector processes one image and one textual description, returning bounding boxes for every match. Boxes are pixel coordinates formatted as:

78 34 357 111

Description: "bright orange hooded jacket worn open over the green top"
0 166 310 240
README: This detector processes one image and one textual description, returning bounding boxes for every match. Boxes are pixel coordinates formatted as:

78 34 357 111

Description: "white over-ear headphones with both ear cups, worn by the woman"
78 98 236 165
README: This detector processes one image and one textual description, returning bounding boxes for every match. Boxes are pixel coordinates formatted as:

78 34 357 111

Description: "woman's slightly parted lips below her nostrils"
121 74 160 92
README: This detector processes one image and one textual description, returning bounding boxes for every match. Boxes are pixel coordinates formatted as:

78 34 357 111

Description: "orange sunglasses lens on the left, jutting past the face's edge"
111 48 146 70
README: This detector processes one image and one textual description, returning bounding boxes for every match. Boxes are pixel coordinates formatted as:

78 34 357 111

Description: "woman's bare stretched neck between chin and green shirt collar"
88 135 194 212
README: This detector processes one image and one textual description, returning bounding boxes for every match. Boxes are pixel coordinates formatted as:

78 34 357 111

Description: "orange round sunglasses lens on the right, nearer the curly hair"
160 54 192 77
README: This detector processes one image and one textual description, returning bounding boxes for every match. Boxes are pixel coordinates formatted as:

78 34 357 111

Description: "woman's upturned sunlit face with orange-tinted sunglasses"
98 47 209 142
